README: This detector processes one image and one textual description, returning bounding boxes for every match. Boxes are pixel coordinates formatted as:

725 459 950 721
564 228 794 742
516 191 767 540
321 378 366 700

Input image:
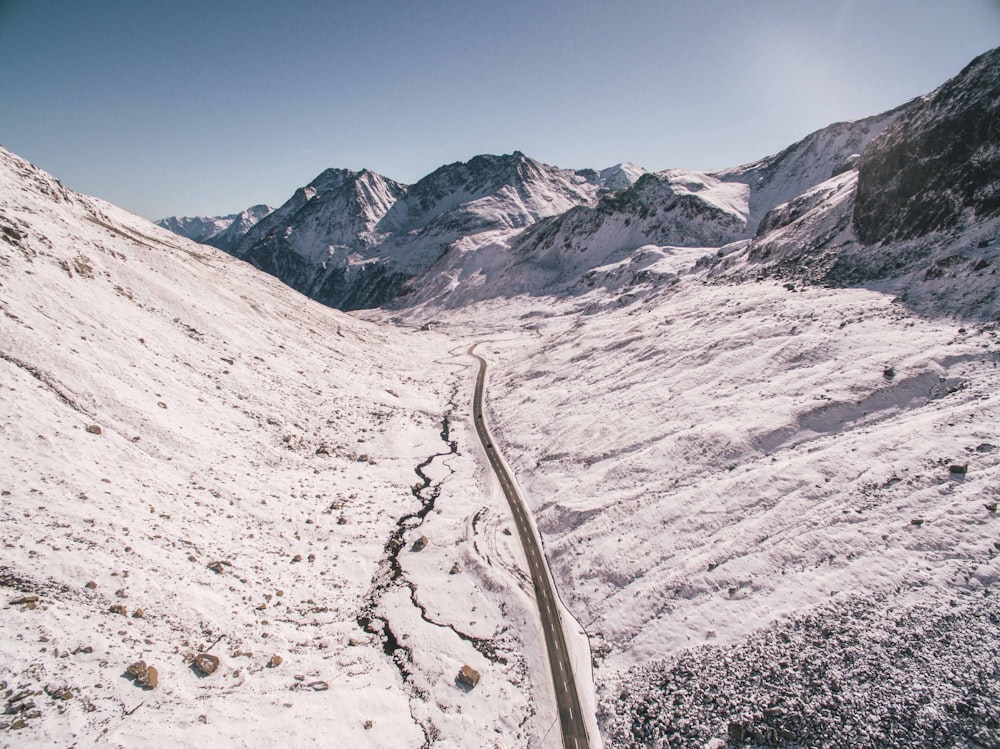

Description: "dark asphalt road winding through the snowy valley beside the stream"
468 344 590 749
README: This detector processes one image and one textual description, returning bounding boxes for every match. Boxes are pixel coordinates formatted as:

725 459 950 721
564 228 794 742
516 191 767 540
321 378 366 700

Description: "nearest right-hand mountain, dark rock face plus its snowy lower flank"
708 50 1000 319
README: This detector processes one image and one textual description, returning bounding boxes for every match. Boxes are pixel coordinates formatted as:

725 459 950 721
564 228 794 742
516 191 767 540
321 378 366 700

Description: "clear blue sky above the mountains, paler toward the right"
0 0 1000 218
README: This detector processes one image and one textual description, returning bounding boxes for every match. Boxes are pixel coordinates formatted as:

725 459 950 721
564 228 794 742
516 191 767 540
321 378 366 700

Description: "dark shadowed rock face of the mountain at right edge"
854 49 1000 245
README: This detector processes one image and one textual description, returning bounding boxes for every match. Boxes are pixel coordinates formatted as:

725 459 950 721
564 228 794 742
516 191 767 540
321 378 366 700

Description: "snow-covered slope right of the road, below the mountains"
390 248 1000 747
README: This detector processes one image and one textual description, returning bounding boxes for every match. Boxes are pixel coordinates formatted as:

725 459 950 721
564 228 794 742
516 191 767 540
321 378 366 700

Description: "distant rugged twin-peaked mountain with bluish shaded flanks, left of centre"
217 152 641 309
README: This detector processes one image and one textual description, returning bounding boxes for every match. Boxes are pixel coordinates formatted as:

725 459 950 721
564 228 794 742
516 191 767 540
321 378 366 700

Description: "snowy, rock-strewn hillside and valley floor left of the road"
0 151 558 747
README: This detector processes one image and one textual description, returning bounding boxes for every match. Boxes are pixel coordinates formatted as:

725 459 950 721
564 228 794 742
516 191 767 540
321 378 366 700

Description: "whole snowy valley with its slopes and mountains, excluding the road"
7 50 1000 749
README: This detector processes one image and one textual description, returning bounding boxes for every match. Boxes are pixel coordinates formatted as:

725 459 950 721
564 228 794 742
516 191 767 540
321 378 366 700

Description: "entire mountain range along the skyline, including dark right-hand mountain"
158 50 1000 310
